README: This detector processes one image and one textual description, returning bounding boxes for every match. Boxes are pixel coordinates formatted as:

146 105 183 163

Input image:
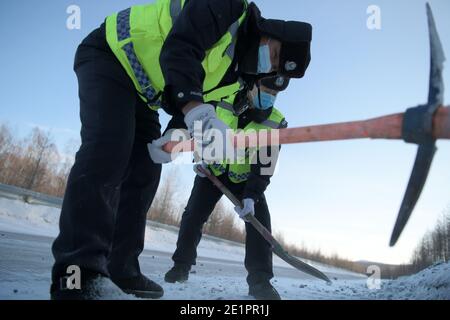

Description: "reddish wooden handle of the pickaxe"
164 107 450 153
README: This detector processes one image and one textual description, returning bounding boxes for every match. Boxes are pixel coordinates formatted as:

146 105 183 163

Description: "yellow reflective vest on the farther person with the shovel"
209 99 286 183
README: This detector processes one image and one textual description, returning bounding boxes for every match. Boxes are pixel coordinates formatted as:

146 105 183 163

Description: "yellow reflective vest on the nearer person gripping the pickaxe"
106 0 247 110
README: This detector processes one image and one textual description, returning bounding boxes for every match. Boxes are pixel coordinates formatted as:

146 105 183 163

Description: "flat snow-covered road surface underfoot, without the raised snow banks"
0 231 367 300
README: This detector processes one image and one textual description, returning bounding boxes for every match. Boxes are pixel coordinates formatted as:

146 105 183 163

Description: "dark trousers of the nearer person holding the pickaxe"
52 28 161 282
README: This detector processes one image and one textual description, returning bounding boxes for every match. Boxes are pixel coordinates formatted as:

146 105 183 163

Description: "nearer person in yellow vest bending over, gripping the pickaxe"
50 0 312 299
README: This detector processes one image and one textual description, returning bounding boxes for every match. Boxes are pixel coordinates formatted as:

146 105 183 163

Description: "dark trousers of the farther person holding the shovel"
172 175 273 285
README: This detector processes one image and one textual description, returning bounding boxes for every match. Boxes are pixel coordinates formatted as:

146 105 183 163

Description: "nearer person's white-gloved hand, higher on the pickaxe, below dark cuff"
184 104 232 163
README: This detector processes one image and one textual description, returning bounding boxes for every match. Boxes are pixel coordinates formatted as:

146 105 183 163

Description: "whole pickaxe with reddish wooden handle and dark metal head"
164 4 450 246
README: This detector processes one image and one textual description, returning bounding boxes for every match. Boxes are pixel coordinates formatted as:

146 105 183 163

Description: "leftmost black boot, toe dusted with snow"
50 270 131 300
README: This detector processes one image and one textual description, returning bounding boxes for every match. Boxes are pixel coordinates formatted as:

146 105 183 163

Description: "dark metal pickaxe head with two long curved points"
390 3 445 246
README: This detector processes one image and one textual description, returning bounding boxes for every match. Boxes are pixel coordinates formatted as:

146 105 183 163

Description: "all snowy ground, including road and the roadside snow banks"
0 198 450 300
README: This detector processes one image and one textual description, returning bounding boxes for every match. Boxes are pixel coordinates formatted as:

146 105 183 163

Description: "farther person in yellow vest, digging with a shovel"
165 77 289 300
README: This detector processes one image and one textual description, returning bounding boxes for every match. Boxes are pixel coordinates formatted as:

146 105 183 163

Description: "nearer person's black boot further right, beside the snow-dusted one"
112 274 164 299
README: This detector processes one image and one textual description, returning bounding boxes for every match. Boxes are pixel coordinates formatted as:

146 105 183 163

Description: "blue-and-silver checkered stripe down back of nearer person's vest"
117 8 161 106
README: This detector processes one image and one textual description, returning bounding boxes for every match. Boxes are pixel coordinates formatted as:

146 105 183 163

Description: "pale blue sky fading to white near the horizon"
0 0 450 263
